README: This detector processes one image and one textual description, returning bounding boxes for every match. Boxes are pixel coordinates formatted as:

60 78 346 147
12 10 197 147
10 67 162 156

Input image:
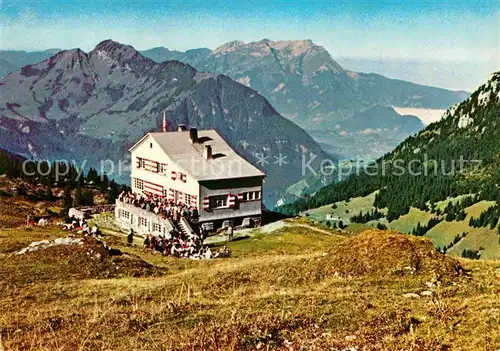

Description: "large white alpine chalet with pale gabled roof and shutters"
115 122 265 234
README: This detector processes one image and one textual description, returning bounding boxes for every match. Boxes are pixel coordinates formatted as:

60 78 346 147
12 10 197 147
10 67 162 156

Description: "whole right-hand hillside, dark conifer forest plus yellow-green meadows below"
280 72 500 257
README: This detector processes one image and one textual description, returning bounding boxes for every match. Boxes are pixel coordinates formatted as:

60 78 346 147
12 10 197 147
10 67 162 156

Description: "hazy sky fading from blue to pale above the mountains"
0 0 500 88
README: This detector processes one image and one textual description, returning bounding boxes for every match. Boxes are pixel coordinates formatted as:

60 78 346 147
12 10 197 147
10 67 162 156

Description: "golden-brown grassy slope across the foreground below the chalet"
0 226 500 350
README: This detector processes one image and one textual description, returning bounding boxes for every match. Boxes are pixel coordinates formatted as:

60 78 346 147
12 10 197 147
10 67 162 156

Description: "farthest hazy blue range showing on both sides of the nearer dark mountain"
0 39 468 158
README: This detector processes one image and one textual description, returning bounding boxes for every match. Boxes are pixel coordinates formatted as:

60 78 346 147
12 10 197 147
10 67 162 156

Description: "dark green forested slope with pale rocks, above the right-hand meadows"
281 72 500 221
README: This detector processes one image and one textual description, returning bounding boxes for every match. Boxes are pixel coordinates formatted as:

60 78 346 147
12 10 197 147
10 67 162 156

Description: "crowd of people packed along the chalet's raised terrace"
118 192 198 221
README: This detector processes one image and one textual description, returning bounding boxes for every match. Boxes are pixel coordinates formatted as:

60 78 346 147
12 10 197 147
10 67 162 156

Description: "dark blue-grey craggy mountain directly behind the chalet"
0 40 327 205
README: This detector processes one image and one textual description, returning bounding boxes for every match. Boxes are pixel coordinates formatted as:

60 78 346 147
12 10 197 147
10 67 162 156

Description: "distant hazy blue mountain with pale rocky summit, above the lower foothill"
142 39 468 117
